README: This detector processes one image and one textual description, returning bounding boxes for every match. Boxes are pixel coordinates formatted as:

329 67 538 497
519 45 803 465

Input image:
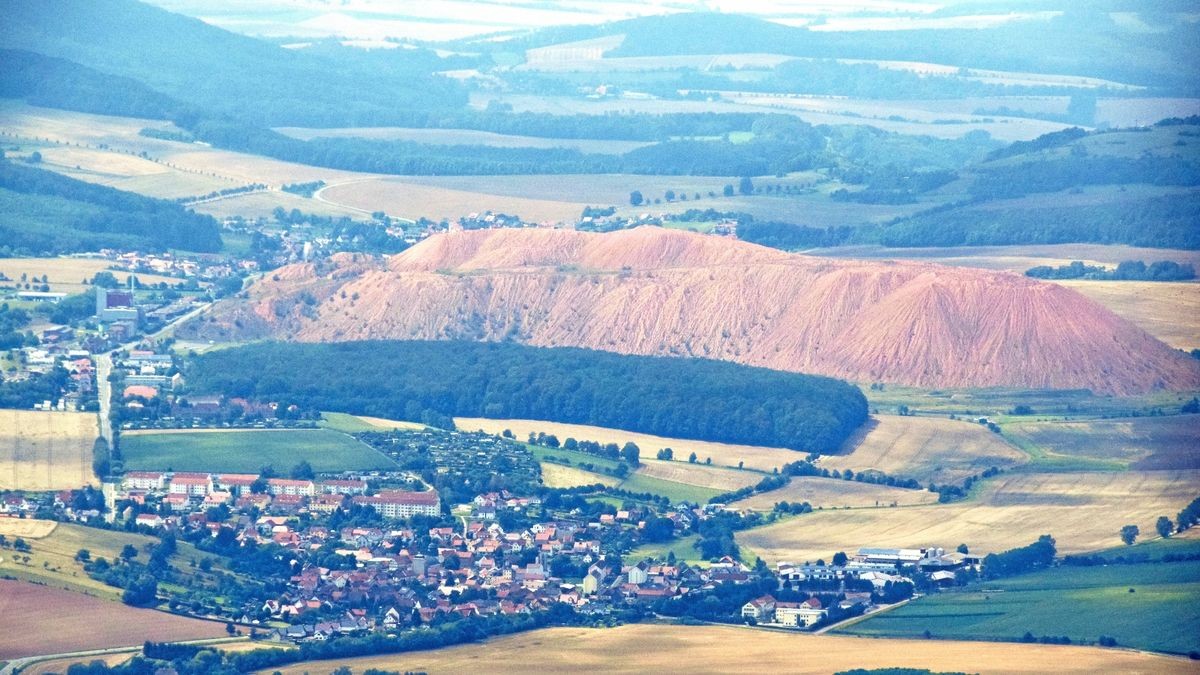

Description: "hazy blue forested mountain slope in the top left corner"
0 0 466 126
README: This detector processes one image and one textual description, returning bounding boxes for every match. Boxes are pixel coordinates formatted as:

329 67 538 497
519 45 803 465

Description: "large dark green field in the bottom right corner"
845 561 1200 653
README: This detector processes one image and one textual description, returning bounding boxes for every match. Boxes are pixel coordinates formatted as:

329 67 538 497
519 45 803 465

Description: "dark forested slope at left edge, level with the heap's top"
0 159 222 256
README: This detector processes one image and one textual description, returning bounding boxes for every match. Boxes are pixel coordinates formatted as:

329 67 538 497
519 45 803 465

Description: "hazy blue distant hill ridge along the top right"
499 11 1200 92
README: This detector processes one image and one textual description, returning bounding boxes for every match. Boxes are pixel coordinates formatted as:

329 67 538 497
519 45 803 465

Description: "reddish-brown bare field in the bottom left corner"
0 580 224 658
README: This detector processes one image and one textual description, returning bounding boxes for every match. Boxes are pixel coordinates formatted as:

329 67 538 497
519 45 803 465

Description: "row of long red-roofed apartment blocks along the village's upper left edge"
115 471 442 527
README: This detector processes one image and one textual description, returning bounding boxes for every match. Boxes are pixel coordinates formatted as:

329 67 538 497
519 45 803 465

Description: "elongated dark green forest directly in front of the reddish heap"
185 341 868 453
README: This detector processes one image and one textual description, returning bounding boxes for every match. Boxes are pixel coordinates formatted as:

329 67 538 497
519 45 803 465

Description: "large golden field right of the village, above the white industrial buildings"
737 471 1200 562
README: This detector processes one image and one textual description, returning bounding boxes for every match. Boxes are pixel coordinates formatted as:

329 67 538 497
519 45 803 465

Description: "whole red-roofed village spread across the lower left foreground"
0 417 980 643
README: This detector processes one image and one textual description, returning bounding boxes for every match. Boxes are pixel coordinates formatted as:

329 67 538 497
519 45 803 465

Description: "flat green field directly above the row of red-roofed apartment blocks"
120 429 395 473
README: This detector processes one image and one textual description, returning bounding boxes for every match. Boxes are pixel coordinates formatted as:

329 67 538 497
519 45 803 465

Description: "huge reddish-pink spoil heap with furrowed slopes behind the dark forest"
180 227 1200 394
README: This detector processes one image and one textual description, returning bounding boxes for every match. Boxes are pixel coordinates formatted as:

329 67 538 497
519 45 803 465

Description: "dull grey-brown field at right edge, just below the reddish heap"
1004 414 1200 470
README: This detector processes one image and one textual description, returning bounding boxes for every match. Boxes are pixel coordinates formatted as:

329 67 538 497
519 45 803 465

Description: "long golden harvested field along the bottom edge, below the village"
267 623 1193 675
